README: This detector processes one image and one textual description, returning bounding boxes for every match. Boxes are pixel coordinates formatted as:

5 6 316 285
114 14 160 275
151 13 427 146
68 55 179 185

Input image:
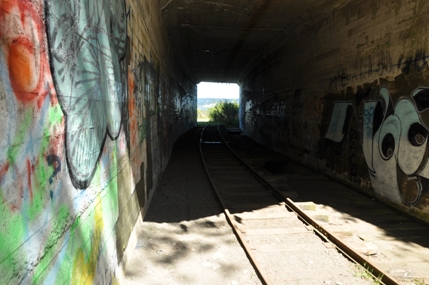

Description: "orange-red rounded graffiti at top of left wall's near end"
0 0 50 105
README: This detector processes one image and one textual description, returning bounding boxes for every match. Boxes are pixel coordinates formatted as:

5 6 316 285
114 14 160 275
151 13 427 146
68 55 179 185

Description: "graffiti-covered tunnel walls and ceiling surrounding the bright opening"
0 0 429 284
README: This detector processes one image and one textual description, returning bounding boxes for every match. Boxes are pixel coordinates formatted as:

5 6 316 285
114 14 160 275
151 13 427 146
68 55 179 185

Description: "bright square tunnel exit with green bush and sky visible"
197 82 240 126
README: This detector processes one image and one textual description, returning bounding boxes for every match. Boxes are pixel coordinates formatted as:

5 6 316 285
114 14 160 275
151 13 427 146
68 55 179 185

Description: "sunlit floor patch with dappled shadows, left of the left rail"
122 215 261 285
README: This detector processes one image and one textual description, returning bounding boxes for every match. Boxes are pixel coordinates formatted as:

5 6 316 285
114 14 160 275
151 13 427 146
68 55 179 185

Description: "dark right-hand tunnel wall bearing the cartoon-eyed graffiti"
240 0 429 222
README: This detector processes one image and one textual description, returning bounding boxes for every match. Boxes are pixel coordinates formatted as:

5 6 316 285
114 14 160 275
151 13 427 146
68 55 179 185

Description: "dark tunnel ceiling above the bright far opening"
160 0 348 83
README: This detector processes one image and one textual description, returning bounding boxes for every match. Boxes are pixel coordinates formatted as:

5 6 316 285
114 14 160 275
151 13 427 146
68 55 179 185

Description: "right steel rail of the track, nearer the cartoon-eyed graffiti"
218 125 400 285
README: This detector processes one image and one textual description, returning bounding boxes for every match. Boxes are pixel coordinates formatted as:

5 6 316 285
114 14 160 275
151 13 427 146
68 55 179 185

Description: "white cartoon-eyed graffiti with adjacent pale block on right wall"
324 86 429 205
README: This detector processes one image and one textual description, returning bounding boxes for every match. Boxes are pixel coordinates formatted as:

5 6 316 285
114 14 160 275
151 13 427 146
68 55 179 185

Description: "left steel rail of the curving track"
200 125 274 285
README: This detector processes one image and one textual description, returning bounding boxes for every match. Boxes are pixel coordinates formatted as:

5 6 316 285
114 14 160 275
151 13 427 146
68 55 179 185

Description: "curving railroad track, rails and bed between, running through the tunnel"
200 126 424 284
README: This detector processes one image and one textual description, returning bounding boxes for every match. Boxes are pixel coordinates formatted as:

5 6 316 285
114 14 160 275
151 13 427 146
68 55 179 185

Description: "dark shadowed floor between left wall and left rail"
144 127 223 223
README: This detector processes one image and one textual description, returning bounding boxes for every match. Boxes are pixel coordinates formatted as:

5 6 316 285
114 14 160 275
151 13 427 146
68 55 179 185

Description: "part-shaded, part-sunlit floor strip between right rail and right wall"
224 132 429 285
